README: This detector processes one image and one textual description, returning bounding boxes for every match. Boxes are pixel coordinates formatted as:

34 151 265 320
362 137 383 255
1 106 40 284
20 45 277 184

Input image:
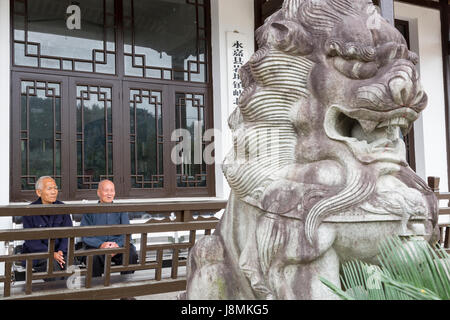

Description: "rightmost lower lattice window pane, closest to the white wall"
175 92 207 188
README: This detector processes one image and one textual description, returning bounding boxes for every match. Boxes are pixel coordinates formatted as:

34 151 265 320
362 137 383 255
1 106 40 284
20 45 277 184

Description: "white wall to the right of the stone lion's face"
394 2 448 191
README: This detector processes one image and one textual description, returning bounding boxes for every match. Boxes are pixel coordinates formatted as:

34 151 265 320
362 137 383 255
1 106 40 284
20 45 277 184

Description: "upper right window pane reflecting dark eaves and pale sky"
123 0 207 83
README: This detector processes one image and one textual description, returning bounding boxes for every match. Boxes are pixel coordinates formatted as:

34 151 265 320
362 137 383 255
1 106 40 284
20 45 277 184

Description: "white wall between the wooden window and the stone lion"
211 0 255 198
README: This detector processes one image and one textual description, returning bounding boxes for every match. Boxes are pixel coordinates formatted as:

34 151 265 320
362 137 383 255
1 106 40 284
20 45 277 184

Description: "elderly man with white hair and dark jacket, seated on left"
22 176 72 280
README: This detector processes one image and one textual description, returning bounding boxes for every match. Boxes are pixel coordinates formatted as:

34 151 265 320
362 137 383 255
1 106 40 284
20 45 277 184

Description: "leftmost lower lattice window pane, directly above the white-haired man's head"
20 80 62 190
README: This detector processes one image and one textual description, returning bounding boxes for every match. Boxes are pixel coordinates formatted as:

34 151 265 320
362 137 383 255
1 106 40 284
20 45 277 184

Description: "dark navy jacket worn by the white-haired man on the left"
22 198 72 264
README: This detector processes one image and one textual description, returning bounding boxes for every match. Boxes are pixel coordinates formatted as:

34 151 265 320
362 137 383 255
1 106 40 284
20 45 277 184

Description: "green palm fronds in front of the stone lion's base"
320 237 450 300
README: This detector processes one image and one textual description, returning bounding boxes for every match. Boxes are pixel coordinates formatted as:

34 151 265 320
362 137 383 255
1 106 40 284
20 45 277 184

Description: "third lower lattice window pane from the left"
130 89 164 189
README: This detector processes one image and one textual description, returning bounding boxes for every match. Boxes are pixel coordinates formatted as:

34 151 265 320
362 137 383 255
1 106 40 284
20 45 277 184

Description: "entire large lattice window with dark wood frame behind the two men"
10 0 215 201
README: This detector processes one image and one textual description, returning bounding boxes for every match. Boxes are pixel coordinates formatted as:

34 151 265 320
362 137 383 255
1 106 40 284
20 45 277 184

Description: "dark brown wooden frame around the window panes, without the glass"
10 0 215 202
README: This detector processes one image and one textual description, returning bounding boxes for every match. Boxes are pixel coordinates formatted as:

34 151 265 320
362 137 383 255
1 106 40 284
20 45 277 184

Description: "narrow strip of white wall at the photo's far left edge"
0 0 12 275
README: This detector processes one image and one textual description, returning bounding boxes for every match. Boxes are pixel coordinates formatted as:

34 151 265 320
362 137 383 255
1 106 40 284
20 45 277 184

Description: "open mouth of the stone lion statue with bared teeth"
324 106 417 165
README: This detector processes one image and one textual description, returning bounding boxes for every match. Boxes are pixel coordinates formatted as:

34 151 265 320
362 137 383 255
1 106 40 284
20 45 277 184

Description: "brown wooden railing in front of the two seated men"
0 201 226 299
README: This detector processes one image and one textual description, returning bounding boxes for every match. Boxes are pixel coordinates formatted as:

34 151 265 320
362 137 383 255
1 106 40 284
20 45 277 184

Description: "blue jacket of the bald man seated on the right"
80 212 130 248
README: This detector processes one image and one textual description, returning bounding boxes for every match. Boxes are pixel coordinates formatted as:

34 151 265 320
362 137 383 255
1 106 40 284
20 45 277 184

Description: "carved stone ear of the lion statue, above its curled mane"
270 20 314 55
